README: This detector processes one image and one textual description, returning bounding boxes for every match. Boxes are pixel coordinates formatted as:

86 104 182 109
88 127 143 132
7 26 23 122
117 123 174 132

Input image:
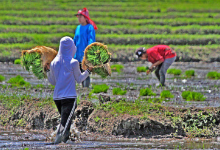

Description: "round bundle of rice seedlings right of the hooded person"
82 42 111 78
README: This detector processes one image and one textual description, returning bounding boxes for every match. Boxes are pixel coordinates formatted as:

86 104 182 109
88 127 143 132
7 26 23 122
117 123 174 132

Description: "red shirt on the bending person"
146 45 176 64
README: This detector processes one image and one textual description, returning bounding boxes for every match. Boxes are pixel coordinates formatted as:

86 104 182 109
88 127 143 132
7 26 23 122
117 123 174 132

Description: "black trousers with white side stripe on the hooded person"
54 98 77 142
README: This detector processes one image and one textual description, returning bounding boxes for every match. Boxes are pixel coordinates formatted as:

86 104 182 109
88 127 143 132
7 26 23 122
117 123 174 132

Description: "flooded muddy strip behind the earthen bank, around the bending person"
0 62 220 107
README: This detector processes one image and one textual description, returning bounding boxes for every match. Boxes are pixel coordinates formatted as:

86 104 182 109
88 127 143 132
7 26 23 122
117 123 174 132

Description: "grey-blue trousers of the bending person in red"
155 56 176 86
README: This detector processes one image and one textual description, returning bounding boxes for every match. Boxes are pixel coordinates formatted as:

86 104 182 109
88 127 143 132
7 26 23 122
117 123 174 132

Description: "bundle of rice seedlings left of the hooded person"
21 46 57 79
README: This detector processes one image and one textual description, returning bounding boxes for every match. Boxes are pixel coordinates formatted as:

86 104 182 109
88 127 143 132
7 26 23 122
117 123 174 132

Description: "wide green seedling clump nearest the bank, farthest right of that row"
182 91 206 101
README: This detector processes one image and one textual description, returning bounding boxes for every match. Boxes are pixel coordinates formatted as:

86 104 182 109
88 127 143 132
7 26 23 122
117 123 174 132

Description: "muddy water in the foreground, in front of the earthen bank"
0 129 220 149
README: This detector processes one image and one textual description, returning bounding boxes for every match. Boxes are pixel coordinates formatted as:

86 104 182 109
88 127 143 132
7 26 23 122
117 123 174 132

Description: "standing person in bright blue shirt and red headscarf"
73 8 98 87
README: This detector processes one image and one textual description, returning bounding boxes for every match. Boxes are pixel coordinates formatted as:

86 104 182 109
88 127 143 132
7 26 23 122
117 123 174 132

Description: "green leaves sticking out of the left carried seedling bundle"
21 53 45 79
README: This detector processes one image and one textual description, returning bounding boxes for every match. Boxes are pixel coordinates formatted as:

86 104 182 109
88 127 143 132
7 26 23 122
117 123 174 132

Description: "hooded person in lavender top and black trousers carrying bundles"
46 36 92 144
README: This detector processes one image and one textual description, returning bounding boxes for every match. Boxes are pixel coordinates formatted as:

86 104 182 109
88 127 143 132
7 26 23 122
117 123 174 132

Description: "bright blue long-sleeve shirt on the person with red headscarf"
73 24 95 63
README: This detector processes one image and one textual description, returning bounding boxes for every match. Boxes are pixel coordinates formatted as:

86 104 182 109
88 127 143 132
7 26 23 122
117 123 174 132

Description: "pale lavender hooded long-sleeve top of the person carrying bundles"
47 37 89 100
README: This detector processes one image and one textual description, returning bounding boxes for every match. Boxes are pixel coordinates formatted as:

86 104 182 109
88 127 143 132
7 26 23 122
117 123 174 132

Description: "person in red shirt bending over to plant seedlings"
135 45 176 86
